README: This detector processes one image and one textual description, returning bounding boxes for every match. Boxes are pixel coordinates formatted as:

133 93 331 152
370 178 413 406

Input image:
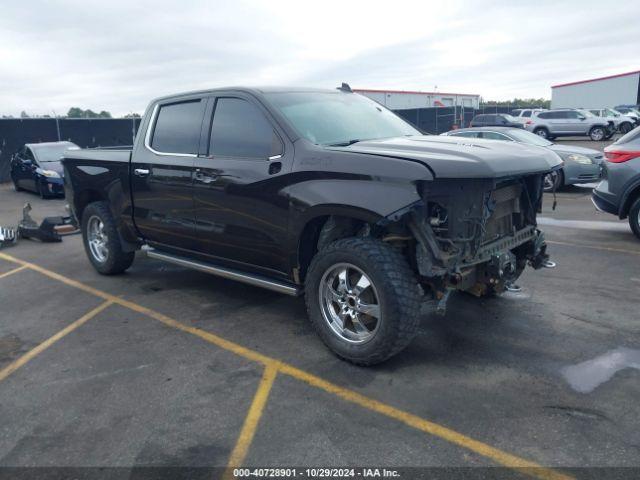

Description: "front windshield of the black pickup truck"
266 92 422 145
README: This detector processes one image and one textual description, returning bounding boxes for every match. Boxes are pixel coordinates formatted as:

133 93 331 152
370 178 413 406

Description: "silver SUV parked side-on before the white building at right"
524 108 615 142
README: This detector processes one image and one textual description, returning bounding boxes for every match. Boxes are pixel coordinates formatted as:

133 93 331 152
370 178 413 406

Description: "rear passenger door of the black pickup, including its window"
131 98 206 250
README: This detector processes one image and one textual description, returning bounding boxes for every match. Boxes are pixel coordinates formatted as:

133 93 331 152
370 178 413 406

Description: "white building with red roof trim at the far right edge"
551 70 640 108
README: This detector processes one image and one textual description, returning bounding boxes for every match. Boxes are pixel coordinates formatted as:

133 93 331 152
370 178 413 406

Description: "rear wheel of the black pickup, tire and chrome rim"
82 202 135 275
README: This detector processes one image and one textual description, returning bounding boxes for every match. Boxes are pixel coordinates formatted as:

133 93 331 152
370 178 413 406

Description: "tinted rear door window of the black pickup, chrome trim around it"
151 100 203 153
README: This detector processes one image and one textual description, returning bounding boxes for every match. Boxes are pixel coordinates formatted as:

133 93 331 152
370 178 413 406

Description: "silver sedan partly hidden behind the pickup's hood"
442 127 603 192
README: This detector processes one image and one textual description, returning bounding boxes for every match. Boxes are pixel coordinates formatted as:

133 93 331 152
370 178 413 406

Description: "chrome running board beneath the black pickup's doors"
142 245 302 297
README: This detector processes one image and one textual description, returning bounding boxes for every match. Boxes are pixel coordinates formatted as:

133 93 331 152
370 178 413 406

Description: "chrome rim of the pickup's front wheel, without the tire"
318 263 382 344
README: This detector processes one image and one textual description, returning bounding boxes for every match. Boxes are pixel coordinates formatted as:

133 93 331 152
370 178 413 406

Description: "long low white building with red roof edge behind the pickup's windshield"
353 88 480 110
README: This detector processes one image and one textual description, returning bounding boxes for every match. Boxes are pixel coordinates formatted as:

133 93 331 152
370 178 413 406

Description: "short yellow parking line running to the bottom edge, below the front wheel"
222 363 278 480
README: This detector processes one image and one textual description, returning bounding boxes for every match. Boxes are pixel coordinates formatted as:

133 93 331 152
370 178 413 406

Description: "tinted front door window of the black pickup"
209 98 281 159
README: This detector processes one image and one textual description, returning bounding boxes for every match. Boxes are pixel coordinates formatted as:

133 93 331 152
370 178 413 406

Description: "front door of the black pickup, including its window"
194 96 293 273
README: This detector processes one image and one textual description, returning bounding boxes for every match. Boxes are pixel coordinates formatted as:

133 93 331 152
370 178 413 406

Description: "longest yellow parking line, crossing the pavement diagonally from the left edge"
0 253 573 480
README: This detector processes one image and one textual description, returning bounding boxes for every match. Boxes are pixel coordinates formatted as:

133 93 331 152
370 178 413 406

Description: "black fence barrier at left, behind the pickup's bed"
0 118 140 182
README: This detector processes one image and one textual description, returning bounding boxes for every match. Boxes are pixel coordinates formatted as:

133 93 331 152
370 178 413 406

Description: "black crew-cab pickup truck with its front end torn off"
63 85 562 365
